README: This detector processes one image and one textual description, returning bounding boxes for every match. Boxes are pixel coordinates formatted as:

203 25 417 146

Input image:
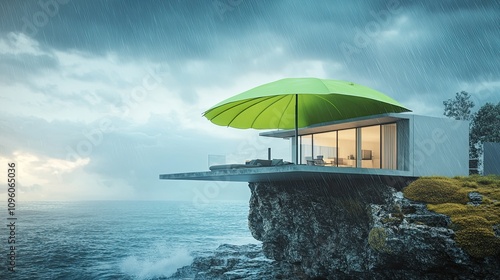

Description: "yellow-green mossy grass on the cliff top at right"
403 175 500 258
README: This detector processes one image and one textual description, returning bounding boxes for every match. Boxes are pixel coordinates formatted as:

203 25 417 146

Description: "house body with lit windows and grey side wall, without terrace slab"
260 113 469 177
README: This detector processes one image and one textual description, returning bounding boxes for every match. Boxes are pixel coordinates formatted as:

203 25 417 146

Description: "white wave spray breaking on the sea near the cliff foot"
120 249 193 280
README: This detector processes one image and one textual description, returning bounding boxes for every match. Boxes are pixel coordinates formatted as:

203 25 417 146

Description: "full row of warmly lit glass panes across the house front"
300 123 398 169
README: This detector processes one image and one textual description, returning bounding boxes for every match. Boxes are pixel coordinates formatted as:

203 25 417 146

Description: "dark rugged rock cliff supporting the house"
248 177 500 279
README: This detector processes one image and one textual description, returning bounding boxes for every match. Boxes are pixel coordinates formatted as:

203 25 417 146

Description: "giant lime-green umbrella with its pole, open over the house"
203 78 410 163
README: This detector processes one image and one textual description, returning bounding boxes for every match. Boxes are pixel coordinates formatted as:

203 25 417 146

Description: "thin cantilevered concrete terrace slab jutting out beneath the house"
160 164 414 182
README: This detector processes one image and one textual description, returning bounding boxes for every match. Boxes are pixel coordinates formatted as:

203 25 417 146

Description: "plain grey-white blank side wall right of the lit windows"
410 115 469 176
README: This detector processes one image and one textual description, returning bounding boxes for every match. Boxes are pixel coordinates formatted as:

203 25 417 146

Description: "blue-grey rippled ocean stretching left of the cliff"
0 201 258 280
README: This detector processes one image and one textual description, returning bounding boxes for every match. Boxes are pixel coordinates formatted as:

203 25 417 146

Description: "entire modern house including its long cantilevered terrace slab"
160 113 469 182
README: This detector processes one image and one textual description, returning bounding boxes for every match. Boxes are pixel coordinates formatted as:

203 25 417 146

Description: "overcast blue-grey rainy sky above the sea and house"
0 0 500 201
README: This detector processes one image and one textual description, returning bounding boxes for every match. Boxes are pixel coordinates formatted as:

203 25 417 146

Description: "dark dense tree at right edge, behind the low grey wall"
469 102 500 158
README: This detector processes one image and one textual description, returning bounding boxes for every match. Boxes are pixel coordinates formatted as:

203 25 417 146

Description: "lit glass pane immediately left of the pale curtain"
360 125 380 168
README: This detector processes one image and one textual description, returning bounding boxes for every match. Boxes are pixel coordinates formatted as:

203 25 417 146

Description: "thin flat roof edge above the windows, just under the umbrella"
259 113 411 138
